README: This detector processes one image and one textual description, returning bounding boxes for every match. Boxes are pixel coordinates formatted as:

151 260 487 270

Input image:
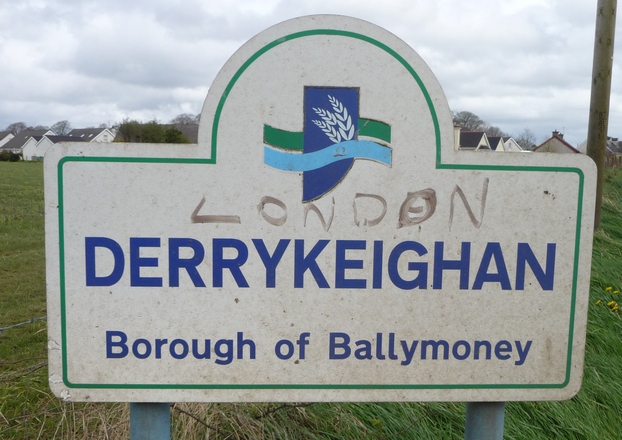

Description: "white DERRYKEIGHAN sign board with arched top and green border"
45 16 595 402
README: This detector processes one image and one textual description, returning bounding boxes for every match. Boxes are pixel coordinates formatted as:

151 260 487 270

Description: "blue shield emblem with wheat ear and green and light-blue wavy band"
264 87 391 202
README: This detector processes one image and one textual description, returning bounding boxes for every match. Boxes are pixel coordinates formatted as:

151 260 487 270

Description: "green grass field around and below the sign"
0 162 622 440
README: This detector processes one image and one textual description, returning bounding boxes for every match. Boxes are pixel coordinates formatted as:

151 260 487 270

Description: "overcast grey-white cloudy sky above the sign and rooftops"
0 0 622 146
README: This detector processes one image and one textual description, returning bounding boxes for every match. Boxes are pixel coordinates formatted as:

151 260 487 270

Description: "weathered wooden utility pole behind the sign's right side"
587 0 617 230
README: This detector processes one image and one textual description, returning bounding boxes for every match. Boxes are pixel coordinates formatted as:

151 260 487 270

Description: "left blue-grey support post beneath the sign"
130 403 171 440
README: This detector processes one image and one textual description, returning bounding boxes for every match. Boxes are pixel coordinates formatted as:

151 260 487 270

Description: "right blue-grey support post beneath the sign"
464 402 505 440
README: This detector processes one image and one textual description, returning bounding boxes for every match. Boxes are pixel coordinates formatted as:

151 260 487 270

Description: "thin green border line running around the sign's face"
58 29 584 390
